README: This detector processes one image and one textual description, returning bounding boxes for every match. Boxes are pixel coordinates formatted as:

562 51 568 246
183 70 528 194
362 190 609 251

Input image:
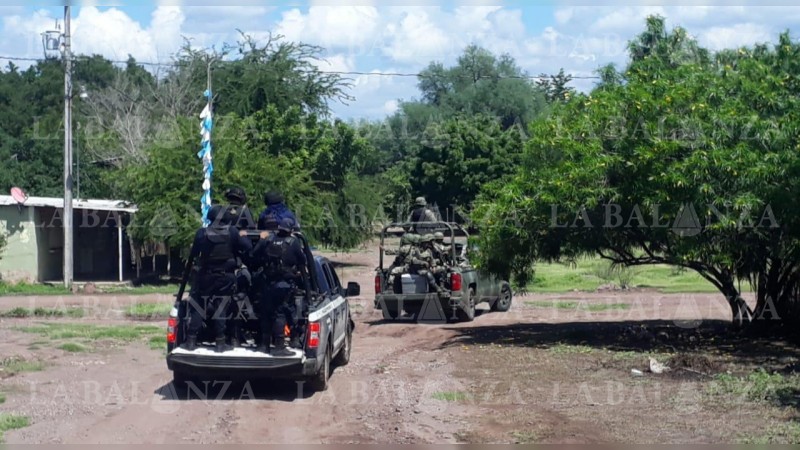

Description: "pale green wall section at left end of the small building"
0 206 39 282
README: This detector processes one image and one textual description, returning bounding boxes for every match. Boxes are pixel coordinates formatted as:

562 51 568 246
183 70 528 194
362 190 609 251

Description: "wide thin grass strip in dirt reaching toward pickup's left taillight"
17 323 163 342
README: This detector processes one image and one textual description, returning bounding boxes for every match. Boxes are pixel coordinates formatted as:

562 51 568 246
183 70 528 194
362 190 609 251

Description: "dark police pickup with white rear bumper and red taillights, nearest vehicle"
167 233 361 391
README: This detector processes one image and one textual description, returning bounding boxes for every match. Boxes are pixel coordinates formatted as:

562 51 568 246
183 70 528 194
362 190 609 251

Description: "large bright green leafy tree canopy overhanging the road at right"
473 18 800 326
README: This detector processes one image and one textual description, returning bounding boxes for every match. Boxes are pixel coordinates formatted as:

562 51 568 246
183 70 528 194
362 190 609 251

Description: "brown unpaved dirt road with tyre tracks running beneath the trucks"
0 243 792 444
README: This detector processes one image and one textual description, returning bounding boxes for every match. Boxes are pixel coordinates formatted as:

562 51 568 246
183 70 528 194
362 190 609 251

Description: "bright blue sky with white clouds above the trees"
0 0 800 119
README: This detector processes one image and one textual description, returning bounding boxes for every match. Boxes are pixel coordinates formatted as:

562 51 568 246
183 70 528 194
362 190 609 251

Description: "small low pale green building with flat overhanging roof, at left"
0 195 137 282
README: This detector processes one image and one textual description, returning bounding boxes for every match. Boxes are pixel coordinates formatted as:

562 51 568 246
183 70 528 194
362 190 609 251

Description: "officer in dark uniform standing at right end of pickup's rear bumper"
253 217 309 356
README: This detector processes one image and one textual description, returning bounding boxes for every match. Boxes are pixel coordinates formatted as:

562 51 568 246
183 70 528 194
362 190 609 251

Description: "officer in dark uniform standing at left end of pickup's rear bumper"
185 205 252 352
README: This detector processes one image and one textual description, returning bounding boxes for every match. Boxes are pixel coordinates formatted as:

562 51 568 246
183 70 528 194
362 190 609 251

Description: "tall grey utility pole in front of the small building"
63 6 73 289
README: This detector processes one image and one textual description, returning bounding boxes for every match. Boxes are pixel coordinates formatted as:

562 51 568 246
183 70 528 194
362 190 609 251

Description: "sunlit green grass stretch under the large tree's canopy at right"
527 257 751 294
